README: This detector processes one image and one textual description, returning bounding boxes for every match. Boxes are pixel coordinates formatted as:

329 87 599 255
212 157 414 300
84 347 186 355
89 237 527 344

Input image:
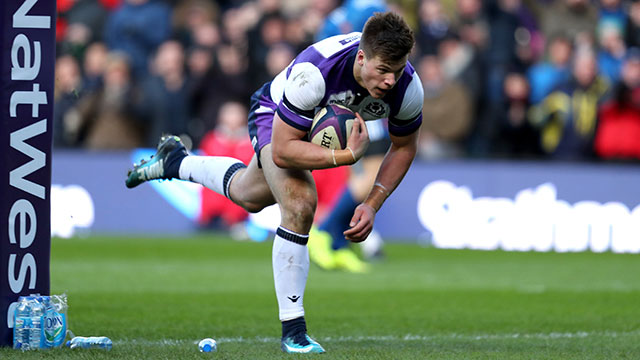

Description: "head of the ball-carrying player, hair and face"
354 12 415 98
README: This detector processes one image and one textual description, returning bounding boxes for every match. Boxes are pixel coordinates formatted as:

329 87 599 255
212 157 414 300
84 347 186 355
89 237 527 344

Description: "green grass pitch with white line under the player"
0 235 640 359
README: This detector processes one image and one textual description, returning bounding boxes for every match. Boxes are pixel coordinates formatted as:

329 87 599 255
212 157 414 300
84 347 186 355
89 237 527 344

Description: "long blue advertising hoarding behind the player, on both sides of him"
52 150 640 253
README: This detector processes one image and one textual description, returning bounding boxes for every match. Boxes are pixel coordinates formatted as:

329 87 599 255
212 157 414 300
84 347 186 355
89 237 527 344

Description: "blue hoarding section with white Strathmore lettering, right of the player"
376 161 640 252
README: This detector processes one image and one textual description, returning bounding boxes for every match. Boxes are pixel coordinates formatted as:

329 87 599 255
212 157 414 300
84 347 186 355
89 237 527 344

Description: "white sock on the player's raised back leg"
178 155 246 197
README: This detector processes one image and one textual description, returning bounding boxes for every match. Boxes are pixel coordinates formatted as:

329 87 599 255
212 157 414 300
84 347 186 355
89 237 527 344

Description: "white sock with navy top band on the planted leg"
272 227 309 321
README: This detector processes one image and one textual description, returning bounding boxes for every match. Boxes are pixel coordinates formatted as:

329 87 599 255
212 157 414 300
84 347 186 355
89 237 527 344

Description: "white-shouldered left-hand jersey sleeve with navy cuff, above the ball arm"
277 62 326 131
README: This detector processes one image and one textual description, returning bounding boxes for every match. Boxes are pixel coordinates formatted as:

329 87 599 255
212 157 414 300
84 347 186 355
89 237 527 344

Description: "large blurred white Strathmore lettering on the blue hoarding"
417 180 640 253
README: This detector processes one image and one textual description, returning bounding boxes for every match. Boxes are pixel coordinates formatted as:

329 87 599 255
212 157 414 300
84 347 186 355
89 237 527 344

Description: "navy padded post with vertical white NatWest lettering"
0 0 56 345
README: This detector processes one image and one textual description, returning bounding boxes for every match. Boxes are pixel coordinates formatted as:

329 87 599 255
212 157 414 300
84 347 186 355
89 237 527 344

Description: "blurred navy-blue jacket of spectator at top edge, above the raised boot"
104 0 171 79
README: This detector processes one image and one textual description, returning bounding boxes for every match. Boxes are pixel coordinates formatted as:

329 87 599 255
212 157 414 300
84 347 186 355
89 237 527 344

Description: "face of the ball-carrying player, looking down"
356 50 408 99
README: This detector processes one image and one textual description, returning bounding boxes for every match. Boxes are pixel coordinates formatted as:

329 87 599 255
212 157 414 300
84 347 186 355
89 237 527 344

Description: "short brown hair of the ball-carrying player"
360 12 415 62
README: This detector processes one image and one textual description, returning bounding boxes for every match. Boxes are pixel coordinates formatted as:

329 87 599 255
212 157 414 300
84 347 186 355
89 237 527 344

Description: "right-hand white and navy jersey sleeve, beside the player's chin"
389 72 424 136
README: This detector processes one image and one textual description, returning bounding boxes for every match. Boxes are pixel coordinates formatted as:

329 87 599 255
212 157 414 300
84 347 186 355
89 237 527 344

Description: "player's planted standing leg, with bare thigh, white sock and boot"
260 145 324 353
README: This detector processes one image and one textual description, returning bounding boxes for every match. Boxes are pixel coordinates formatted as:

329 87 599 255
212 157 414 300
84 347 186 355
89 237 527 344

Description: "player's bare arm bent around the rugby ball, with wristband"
271 113 369 170
